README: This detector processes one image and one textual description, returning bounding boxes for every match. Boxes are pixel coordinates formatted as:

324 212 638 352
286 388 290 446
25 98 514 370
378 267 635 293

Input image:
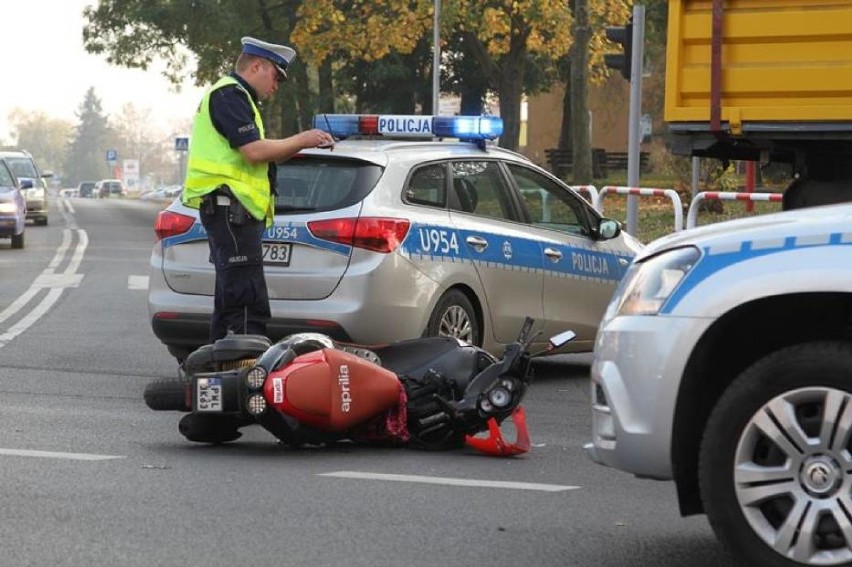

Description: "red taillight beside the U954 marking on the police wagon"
308 217 411 254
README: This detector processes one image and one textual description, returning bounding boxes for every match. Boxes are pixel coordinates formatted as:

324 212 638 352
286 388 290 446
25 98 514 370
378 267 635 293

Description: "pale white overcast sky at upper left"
0 0 202 144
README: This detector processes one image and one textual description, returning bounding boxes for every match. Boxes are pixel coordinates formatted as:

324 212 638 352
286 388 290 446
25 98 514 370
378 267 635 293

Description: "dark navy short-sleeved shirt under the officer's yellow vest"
210 73 276 194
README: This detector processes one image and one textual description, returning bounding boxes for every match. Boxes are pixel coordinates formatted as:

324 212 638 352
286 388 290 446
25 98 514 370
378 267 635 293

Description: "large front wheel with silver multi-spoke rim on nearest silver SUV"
699 342 852 567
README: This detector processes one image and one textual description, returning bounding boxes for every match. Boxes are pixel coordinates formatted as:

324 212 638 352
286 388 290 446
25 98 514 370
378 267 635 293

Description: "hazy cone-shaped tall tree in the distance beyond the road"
64 87 112 185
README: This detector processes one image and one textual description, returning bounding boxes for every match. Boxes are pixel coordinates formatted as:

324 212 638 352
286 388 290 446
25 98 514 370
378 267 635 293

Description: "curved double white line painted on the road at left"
0 228 89 348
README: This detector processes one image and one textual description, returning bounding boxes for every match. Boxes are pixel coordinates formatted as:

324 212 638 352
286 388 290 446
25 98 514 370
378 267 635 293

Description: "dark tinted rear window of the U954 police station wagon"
275 156 382 214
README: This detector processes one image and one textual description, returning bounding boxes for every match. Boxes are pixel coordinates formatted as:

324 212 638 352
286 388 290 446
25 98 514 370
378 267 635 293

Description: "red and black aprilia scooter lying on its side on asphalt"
144 318 575 456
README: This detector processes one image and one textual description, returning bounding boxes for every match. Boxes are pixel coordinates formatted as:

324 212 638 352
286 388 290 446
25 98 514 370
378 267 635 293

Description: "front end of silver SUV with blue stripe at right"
586 205 852 566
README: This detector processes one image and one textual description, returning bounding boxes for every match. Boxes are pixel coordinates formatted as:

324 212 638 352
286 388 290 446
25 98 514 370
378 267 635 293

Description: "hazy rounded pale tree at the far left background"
9 108 74 175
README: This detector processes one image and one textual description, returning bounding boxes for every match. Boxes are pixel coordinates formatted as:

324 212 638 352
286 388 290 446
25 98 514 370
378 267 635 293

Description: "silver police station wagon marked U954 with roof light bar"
148 115 641 358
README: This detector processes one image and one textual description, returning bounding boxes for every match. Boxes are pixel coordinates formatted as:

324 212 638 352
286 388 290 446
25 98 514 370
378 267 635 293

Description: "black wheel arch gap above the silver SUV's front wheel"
671 293 852 516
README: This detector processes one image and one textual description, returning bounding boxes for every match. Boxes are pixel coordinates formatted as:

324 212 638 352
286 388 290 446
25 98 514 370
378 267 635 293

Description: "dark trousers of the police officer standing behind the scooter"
199 196 271 343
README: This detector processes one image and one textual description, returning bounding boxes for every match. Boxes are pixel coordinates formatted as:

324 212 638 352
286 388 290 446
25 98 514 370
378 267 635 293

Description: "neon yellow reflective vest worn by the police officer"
181 76 274 226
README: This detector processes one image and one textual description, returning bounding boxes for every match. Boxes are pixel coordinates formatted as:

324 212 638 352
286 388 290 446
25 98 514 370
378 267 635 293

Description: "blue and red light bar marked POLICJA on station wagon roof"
314 114 503 141
